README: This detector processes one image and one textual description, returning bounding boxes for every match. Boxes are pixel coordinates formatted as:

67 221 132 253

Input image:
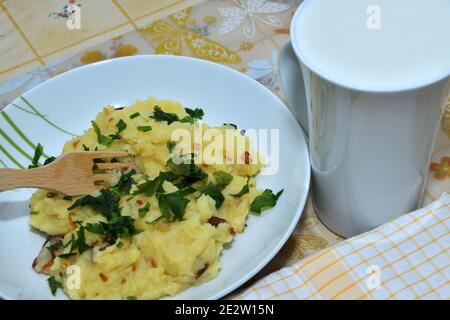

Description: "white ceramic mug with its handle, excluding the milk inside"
279 0 450 237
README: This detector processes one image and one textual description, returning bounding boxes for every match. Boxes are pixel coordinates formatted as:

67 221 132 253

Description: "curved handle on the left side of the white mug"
278 41 308 135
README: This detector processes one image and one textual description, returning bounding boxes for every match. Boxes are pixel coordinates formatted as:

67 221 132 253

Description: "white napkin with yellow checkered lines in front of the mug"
235 194 450 300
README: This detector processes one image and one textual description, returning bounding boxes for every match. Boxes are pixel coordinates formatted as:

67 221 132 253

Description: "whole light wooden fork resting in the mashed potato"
0 151 132 196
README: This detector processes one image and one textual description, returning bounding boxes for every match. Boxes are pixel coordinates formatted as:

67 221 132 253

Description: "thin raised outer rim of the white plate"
0 54 311 300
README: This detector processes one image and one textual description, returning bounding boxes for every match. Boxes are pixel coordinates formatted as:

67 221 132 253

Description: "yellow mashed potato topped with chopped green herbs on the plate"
30 98 278 299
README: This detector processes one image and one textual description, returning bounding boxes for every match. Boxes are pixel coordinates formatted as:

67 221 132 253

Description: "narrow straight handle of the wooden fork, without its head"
0 168 51 191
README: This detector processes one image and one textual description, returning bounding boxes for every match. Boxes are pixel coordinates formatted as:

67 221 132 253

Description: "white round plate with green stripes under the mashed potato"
0 56 310 299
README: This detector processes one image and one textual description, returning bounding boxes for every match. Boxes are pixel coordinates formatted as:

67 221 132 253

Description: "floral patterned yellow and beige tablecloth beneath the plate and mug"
0 0 450 296
